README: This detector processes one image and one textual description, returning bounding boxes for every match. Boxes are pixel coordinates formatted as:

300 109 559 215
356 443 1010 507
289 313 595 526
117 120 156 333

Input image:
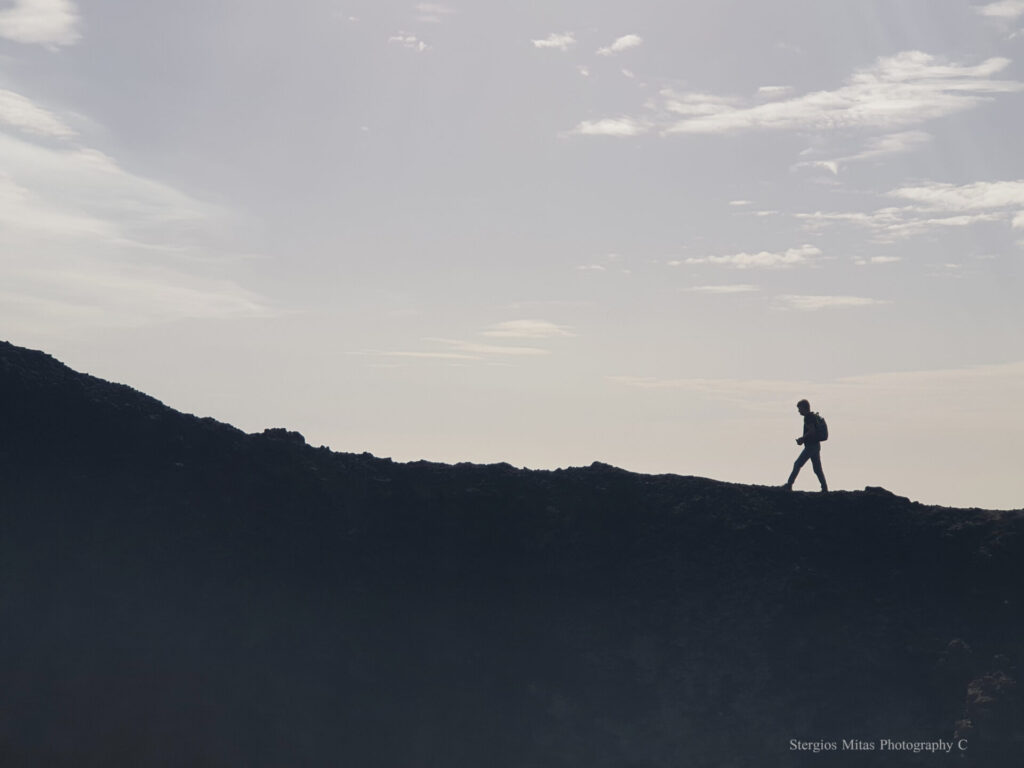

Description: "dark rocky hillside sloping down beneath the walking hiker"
0 343 1024 768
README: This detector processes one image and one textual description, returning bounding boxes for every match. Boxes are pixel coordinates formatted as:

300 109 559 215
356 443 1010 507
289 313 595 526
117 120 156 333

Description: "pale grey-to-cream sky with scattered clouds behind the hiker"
0 0 1024 508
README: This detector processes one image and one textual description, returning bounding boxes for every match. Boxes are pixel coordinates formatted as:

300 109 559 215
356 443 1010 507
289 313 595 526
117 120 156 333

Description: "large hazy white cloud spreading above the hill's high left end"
0 91 275 334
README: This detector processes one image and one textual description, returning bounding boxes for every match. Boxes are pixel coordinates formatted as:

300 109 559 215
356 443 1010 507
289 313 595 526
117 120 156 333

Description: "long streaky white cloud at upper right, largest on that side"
643 51 1024 134
